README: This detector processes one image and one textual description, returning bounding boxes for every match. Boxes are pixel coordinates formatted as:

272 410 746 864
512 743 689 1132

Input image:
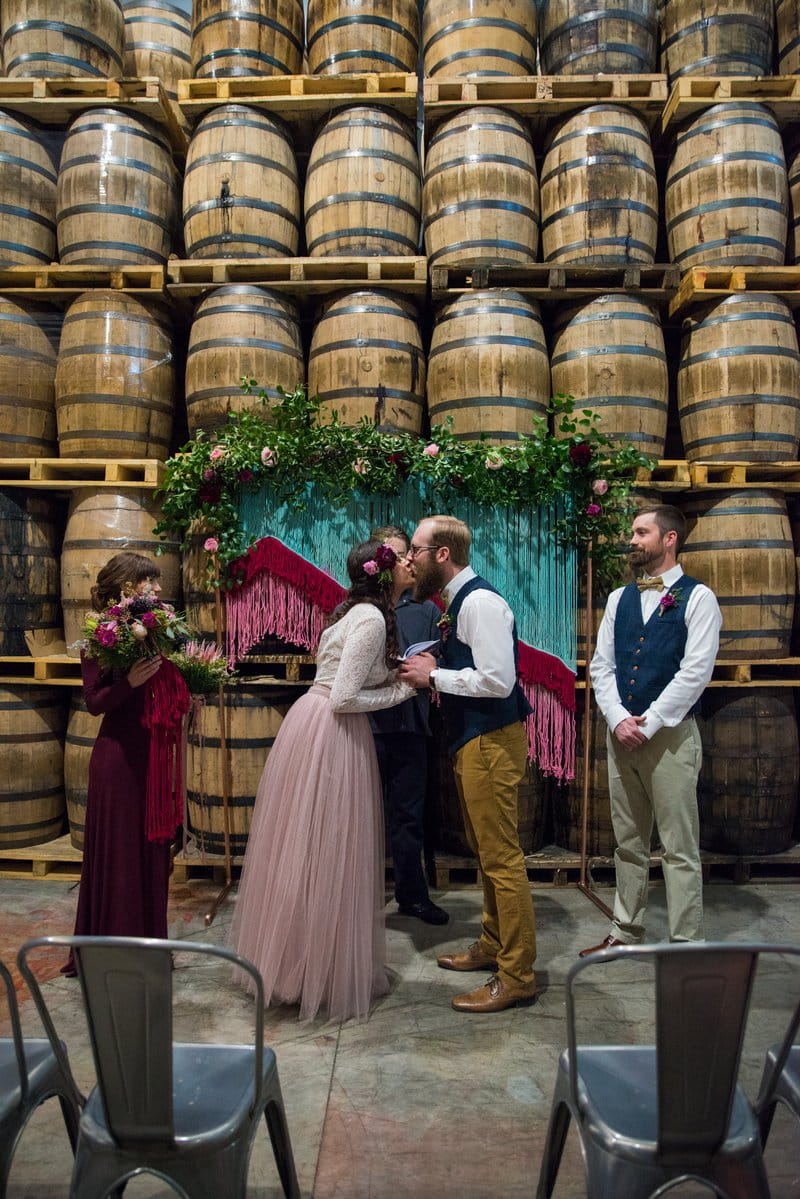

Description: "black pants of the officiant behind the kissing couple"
375 733 428 906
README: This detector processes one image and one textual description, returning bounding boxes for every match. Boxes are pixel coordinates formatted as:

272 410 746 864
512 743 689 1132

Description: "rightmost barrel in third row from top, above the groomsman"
678 293 800 462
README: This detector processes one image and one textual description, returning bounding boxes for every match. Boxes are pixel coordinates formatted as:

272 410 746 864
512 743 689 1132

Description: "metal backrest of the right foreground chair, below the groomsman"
567 942 800 1164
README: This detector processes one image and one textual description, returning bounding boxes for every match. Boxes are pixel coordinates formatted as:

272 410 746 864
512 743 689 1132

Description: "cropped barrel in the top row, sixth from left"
539 0 658 76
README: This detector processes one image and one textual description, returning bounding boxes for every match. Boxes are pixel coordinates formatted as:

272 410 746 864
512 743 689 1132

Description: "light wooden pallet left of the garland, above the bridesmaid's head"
0 458 166 490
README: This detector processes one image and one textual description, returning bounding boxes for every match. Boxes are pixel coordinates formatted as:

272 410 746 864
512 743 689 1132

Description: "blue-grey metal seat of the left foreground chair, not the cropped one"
82 1044 276 1151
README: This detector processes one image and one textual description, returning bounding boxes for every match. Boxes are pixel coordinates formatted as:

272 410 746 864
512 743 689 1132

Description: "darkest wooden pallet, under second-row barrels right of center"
431 260 680 305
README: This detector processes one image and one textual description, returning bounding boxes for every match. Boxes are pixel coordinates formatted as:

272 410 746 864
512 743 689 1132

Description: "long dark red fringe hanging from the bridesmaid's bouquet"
144 658 192 842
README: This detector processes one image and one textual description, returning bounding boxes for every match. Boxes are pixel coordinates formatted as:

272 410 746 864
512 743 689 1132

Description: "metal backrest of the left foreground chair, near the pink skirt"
18 936 264 1145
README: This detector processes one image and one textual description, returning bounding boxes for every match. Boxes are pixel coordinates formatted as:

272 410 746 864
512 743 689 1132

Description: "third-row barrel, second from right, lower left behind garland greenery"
551 295 669 458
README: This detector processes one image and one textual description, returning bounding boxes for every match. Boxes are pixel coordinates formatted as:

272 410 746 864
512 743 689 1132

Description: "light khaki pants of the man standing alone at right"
607 717 703 945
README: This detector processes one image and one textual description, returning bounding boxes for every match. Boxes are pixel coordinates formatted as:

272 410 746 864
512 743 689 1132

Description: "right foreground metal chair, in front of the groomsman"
536 942 800 1199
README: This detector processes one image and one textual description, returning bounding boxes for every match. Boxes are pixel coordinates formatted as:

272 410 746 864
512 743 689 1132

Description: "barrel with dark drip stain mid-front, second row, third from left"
184 104 300 258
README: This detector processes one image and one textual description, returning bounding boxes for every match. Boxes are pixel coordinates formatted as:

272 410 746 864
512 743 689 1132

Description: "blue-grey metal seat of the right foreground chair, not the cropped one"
573 1046 759 1161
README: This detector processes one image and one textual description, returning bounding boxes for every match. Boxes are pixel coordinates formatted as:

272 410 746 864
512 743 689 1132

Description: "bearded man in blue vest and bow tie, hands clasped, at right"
581 504 722 957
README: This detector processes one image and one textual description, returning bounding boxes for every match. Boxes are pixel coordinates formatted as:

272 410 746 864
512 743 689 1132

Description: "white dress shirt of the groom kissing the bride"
431 566 517 699
